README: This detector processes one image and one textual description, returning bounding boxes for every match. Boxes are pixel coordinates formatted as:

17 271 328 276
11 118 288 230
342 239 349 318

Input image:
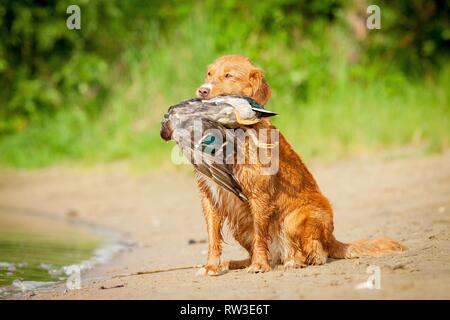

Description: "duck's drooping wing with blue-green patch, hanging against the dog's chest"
174 118 248 201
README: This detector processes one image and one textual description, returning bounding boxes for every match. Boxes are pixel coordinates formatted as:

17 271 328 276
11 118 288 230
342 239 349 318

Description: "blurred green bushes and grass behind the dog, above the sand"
0 0 450 168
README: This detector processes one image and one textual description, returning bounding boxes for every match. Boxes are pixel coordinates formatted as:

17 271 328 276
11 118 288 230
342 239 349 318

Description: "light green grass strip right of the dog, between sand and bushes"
275 71 450 161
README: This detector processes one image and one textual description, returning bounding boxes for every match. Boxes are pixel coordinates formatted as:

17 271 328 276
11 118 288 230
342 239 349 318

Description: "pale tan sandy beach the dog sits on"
0 150 450 299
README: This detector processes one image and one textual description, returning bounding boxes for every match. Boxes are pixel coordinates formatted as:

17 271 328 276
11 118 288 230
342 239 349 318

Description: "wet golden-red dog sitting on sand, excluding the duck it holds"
197 55 406 275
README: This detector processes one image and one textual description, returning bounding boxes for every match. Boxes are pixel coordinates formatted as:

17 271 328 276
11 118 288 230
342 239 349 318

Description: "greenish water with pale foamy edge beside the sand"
0 211 125 299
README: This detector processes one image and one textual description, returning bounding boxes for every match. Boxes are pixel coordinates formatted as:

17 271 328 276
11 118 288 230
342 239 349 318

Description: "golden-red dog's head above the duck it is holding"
197 55 272 105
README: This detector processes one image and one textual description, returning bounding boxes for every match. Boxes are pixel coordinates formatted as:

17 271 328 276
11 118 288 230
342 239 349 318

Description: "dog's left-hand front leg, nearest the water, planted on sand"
197 196 222 276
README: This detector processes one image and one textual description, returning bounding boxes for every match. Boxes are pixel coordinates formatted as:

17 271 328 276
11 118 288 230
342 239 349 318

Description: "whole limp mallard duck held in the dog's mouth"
160 95 276 201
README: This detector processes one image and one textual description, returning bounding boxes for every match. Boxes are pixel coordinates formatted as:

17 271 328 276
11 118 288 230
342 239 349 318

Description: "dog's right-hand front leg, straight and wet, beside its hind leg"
248 195 273 273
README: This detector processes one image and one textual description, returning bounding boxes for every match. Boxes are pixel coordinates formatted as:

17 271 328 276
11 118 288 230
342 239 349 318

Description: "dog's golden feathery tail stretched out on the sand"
329 237 408 259
